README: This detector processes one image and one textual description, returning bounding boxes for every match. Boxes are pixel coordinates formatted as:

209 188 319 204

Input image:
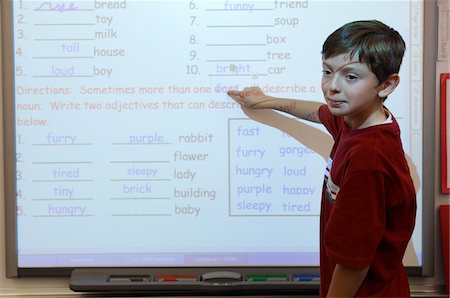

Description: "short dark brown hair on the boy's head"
322 20 405 84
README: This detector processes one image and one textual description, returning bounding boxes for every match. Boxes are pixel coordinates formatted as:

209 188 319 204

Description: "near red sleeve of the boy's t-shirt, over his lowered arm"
324 171 386 268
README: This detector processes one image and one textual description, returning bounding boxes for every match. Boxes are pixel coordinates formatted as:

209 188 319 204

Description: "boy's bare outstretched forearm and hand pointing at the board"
228 87 323 123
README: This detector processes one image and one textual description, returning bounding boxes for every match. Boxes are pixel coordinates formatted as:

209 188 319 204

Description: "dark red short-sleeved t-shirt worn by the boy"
319 105 416 297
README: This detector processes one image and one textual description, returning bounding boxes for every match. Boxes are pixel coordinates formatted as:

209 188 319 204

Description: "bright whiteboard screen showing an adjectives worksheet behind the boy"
2 0 423 269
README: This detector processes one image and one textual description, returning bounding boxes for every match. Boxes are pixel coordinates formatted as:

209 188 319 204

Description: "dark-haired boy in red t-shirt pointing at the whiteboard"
229 21 416 297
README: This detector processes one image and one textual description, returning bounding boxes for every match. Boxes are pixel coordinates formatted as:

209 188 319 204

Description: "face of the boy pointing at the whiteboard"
322 54 384 128
